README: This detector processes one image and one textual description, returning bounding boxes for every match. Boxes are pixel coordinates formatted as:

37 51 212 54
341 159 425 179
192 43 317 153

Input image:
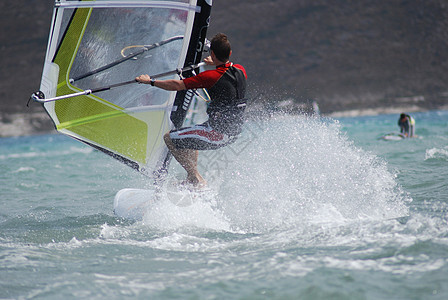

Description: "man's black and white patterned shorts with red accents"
170 122 236 150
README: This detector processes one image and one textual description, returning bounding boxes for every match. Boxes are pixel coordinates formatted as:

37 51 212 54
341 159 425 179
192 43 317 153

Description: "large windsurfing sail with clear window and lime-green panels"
33 0 212 176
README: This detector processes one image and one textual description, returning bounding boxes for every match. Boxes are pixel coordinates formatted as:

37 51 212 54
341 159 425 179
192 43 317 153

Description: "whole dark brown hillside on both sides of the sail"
0 0 448 135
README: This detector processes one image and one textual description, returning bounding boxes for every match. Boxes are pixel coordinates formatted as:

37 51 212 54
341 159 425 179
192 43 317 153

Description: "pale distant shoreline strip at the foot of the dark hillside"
0 105 448 138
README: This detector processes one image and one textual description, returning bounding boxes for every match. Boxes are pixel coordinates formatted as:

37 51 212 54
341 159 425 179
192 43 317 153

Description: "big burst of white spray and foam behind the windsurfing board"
134 116 410 233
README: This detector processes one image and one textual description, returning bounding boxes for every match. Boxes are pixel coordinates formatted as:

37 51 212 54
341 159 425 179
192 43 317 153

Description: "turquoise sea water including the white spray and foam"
0 111 448 299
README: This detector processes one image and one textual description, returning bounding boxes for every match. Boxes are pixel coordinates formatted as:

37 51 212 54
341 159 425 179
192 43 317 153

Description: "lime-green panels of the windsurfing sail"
54 8 148 164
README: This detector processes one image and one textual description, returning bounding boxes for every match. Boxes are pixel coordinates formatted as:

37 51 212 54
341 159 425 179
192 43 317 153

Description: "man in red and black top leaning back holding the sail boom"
136 33 247 187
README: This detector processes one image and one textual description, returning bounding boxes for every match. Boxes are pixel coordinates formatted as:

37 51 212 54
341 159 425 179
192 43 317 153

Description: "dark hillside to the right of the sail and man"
209 0 448 112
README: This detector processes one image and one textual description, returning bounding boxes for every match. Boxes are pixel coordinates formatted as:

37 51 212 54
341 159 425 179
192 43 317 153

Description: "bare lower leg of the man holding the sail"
163 133 206 186
